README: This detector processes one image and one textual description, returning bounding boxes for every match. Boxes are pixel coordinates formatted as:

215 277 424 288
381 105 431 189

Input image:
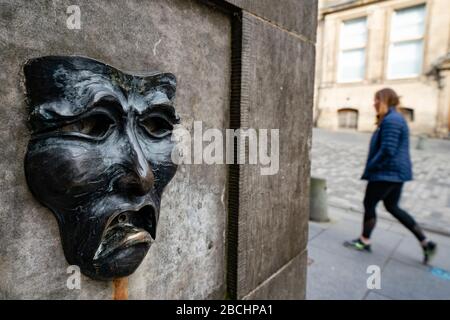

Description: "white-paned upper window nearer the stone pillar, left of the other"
338 17 367 82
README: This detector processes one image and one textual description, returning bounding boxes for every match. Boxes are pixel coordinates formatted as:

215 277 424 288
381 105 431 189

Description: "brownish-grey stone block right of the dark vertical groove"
237 12 314 297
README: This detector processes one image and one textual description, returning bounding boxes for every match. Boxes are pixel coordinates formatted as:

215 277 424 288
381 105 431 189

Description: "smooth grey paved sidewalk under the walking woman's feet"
306 207 450 300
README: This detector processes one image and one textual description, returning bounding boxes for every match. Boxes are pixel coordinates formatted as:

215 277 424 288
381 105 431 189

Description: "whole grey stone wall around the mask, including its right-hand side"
0 0 317 299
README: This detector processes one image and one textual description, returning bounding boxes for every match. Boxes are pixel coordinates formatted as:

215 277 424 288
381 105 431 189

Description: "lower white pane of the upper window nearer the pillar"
338 49 366 82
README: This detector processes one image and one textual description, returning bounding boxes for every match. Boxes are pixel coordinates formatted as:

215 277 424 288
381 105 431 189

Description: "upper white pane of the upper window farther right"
391 6 425 41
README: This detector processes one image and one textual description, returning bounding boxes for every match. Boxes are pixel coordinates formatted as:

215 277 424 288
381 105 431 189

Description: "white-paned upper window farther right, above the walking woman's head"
388 5 425 79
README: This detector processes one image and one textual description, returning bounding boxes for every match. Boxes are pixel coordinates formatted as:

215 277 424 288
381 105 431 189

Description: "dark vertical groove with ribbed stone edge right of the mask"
227 11 255 299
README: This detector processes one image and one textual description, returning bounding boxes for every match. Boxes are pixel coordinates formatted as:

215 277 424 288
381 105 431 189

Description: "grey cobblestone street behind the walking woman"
311 129 450 235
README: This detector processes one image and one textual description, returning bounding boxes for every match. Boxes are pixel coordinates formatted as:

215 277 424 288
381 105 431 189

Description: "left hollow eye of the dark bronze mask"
57 114 114 138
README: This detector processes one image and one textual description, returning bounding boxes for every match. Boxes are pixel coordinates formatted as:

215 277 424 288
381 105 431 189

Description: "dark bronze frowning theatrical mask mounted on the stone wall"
24 56 179 280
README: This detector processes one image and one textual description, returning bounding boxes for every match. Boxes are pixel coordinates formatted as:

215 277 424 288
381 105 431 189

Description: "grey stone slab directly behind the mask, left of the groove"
0 0 231 299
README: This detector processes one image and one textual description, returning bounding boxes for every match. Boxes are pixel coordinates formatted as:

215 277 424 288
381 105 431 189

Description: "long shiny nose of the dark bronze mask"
116 124 155 196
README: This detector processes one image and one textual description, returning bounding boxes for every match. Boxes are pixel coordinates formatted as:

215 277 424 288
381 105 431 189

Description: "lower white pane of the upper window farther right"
388 40 423 78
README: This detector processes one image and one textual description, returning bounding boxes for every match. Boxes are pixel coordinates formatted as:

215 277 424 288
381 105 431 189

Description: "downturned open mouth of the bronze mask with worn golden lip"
94 205 157 261
